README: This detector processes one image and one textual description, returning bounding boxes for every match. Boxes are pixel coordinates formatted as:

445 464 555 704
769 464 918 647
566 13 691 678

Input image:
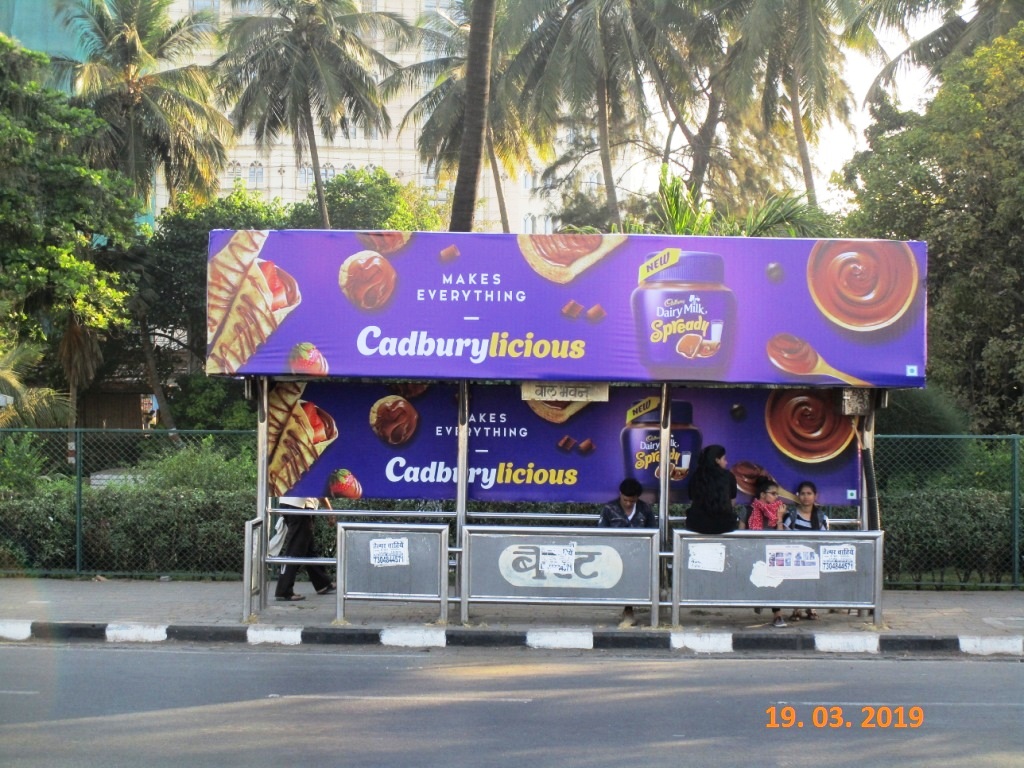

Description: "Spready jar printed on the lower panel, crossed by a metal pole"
622 397 700 503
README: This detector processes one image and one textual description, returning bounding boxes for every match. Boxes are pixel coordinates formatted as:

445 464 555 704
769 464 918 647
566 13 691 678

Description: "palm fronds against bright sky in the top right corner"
862 0 1024 100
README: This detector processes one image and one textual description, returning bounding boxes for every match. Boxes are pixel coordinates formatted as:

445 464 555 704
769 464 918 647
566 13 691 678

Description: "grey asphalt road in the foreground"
0 644 1024 768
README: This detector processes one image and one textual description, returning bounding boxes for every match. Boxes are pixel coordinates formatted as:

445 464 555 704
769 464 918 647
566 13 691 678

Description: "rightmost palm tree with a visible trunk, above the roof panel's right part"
734 0 881 205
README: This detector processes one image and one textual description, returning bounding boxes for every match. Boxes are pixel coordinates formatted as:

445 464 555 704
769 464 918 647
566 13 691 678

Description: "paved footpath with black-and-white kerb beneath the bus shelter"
0 579 1024 657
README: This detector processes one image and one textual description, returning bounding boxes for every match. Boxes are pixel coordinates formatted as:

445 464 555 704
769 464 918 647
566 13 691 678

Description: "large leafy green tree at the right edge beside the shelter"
845 25 1024 433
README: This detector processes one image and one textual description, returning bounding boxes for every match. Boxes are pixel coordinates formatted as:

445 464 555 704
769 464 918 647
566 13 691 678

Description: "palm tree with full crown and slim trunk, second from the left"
216 0 414 228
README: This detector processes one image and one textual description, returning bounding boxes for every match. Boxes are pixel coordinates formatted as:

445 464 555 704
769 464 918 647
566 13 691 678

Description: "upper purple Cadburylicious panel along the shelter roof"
207 230 927 387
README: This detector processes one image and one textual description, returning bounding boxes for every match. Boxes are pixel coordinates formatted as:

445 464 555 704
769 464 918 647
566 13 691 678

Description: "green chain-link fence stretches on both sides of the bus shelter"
0 429 1022 589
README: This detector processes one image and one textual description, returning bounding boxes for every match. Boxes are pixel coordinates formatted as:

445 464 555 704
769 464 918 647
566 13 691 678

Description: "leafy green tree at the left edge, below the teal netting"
0 36 138 352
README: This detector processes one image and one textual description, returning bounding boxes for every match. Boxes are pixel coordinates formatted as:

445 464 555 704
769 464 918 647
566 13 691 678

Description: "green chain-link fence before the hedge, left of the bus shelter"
0 429 256 578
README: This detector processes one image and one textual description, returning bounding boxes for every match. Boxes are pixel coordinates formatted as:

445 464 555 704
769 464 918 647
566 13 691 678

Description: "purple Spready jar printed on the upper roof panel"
632 248 736 377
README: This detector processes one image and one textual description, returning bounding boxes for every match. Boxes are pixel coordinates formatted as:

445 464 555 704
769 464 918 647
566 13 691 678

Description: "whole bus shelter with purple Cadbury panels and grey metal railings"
201 230 927 624
